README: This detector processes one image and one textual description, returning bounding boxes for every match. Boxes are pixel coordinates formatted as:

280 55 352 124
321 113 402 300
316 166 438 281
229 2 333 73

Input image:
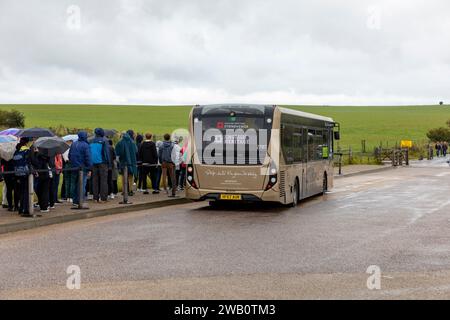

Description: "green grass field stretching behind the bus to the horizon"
0 105 450 150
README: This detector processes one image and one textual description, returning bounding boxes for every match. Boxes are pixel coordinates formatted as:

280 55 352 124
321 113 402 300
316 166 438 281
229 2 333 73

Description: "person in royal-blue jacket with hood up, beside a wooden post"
69 131 92 206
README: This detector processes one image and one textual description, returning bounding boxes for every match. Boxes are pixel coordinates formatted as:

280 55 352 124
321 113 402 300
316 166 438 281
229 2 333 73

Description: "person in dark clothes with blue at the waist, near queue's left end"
13 138 31 217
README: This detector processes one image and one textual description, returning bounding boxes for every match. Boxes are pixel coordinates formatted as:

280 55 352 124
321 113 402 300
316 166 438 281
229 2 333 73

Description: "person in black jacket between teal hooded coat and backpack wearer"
138 133 159 194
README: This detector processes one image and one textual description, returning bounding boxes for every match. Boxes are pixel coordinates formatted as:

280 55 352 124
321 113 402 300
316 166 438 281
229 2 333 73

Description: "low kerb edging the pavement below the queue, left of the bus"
0 198 190 234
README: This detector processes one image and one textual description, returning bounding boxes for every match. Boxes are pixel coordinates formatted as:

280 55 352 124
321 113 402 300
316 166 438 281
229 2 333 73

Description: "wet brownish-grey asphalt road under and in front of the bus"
0 159 450 298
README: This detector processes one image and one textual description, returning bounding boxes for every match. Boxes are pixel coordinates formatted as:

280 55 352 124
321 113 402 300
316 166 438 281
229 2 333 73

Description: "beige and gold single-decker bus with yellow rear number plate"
186 104 339 206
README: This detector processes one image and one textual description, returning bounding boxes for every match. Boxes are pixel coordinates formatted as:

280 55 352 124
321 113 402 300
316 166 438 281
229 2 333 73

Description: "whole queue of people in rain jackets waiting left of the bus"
0 128 186 216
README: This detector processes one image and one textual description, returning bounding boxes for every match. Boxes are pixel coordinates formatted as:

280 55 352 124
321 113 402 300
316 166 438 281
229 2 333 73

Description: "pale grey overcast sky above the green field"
0 0 450 105
